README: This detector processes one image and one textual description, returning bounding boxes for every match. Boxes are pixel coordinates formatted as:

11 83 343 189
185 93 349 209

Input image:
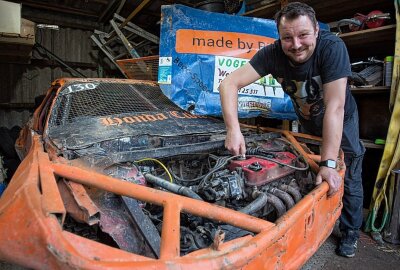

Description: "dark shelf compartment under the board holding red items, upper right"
339 24 396 58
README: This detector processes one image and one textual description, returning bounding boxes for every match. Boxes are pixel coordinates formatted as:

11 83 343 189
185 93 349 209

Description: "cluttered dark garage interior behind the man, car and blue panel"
0 0 400 269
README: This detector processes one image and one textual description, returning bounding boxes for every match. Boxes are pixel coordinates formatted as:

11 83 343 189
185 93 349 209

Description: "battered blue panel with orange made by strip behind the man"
158 5 297 120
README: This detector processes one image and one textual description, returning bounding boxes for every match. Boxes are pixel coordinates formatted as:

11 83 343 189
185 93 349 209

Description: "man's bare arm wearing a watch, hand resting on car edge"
316 78 347 195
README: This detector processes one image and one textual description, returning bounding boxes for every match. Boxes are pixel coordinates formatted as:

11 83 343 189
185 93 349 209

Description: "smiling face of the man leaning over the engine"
279 16 319 64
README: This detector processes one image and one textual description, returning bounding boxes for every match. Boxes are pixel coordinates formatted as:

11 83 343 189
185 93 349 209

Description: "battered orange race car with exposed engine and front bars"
0 79 345 270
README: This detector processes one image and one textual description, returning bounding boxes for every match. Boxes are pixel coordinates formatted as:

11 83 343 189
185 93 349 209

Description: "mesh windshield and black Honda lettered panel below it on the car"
48 81 225 153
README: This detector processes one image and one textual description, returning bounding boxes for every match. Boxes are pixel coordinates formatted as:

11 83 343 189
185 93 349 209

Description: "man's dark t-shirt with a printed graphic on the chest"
250 30 357 136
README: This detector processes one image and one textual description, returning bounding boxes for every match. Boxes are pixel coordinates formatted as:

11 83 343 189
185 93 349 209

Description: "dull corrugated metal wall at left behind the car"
0 19 99 127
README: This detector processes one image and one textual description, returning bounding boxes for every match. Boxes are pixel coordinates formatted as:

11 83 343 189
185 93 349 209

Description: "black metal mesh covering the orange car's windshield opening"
50 83 179 125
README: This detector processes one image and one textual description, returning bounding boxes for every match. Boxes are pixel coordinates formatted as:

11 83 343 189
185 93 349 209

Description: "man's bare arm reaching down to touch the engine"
219 63 260 155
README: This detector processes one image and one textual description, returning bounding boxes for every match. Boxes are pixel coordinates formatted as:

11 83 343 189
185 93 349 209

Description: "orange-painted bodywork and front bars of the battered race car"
0 79 345 270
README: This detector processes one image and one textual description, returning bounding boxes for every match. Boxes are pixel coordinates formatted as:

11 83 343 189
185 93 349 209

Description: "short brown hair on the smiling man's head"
275 2 317 31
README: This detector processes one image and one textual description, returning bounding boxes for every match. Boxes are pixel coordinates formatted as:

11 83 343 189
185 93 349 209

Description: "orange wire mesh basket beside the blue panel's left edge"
117 55 158 81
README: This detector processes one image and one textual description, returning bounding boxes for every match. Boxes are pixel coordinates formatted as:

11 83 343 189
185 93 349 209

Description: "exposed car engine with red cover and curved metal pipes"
109 138 313 254
